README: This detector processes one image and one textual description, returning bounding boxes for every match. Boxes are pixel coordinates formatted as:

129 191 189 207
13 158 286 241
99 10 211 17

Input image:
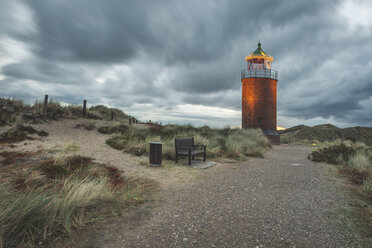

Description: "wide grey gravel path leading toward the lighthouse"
82 145 354 247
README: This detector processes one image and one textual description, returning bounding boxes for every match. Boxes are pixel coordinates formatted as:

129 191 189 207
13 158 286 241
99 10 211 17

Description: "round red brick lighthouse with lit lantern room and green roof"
242 43 280 144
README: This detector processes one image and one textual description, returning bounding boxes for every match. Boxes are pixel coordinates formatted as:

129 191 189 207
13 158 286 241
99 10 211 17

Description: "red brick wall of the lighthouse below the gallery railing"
242 78 278 131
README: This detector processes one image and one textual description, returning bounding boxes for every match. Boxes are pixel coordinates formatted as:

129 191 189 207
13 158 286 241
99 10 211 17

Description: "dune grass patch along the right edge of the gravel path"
309 140 372 195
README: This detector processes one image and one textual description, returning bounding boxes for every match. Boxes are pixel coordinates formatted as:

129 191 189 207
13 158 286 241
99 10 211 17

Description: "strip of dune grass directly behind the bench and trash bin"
106 125 270 160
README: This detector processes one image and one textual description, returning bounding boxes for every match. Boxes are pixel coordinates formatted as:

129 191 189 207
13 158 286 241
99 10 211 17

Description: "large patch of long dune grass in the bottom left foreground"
0 156 151 247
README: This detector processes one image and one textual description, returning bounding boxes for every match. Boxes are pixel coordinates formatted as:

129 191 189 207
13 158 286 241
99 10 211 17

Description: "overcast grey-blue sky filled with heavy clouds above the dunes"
0 0 372 127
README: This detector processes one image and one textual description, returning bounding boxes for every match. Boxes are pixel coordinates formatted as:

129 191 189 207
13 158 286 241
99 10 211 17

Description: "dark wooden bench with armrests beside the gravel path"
174 138 207 165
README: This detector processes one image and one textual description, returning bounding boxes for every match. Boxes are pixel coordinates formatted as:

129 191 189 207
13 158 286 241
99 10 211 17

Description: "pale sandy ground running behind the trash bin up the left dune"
0 119 230 188
